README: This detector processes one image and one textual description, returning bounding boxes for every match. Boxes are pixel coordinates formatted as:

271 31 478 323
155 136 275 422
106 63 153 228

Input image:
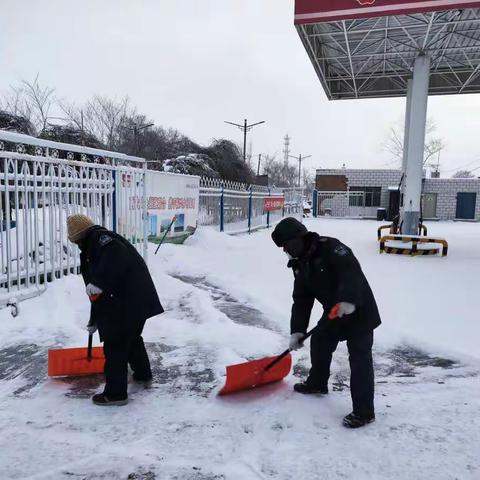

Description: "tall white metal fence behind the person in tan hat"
0 131 147 310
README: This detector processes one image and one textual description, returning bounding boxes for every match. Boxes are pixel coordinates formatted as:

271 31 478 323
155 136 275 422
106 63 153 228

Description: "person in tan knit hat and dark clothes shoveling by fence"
67 215 163 405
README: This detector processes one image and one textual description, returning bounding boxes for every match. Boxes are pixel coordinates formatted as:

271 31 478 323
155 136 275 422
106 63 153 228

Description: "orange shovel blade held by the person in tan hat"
48 347 105 377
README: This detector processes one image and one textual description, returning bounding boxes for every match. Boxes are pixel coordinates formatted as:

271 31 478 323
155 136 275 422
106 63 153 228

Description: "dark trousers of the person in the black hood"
307 329 375 415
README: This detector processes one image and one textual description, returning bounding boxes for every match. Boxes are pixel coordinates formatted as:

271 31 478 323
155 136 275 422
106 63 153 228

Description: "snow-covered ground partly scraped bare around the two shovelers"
0 219 480 480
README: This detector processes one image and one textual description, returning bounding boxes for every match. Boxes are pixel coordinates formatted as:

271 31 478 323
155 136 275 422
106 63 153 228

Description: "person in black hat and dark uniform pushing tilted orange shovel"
272 217 381 428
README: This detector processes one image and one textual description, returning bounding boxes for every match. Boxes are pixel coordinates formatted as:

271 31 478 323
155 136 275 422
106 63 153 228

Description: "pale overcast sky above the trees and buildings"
0 0 480 176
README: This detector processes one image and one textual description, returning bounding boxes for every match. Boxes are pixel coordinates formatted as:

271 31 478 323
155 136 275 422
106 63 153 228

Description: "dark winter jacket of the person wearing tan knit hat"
80 226 163 337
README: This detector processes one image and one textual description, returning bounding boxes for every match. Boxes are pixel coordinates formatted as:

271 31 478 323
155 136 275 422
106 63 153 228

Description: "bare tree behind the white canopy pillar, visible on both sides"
382 119 445 168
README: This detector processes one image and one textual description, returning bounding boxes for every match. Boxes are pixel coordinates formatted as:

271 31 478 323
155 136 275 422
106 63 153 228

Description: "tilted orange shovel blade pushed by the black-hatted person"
218 354 292 395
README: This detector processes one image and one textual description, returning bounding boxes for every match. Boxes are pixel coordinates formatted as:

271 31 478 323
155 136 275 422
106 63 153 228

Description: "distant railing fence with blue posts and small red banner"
198 178 303 233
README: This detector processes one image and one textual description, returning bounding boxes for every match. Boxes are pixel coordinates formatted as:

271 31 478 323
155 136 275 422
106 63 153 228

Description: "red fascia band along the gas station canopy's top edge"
295 0 480 25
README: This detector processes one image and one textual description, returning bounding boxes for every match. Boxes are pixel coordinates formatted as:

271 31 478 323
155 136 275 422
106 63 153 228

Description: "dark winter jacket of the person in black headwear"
288 232 381 340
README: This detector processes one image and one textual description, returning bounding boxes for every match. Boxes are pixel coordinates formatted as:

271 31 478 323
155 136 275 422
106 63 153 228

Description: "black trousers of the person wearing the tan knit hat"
103 334 152 399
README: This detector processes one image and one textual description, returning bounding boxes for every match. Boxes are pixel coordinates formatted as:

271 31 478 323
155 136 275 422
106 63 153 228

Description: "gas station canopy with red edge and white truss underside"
295 0 480 100
